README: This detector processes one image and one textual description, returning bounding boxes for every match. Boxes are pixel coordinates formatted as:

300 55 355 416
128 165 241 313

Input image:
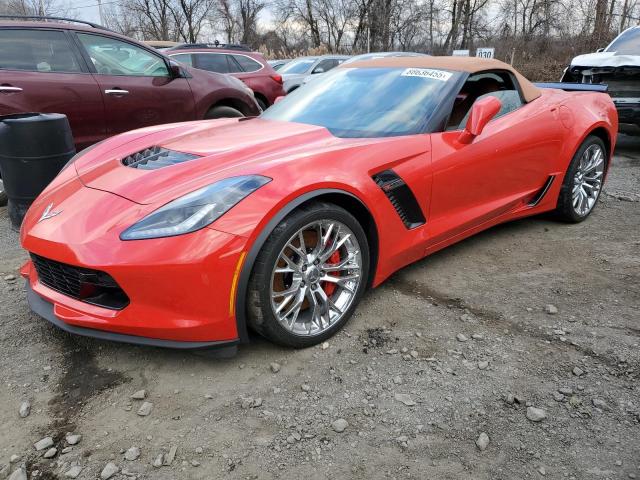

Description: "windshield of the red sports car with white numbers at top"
262 68 459 137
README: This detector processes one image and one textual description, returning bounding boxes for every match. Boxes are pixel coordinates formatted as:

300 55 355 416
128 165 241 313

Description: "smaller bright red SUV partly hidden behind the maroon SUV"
165 42 286 110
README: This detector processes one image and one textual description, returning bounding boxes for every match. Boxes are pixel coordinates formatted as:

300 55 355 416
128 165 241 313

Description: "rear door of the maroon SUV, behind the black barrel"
0 27 107 150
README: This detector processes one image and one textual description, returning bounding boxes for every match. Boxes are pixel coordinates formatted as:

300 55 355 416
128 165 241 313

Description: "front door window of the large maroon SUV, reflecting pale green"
78 33 169 77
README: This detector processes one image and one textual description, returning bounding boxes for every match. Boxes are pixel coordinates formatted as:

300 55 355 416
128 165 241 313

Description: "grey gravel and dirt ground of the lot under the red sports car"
0 133 640 480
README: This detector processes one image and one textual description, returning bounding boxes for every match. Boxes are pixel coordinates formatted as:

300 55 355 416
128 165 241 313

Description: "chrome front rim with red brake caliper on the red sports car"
270 220 362 336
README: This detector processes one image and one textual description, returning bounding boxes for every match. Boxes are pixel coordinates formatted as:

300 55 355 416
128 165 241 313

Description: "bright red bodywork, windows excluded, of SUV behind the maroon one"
167 48 286 107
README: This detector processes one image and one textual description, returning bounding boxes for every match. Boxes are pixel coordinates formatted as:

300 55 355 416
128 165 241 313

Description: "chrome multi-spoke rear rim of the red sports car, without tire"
572 145 605 217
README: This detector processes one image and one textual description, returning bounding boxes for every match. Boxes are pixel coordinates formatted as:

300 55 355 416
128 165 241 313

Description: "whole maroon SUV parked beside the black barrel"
0 17 260 150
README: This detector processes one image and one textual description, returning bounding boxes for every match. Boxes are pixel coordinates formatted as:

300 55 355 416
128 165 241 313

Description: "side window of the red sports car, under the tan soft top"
447 71 524 130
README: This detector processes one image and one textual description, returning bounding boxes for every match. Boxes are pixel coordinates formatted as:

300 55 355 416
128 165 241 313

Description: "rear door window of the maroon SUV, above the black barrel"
0 28 82 73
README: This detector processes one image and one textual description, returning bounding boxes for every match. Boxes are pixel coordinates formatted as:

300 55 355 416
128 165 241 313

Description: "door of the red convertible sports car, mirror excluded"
428 74 562 247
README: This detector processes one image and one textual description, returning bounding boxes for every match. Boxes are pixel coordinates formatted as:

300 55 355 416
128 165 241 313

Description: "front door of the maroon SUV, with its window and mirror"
77 32 196 135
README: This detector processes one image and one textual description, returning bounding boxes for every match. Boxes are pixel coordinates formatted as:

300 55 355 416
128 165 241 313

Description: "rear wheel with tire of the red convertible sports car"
556 136 607 223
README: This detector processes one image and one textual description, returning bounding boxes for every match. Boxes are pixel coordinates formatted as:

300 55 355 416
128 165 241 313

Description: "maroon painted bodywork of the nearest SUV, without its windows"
0 22 260 151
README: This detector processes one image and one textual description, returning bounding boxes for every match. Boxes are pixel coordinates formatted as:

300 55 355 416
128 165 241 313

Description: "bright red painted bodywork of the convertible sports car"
21 82 617 342
